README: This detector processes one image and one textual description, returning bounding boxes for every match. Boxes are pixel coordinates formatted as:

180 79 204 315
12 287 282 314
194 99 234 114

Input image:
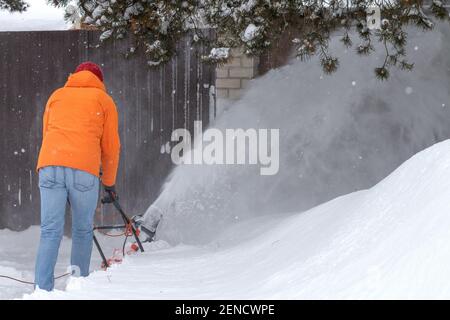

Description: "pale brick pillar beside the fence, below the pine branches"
216 49 258 100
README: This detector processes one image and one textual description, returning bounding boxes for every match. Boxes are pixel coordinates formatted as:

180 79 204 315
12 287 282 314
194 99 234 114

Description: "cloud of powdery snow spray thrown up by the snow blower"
147 24 450 244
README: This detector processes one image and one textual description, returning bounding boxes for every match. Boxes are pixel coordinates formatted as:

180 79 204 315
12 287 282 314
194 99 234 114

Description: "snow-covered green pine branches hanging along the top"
43 0 450 79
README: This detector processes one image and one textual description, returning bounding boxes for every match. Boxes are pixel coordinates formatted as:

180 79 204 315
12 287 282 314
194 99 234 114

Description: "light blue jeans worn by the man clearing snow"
35 166 99 291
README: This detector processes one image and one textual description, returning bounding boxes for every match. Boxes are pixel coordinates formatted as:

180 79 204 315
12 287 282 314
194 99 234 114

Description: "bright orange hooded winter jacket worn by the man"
37 71 120 186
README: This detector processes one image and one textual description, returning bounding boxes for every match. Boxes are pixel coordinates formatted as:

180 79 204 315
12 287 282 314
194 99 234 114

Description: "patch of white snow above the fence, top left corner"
0 0 68 31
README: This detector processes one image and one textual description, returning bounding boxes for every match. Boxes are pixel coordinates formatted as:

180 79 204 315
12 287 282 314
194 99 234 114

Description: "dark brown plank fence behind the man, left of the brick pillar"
0 31 215 230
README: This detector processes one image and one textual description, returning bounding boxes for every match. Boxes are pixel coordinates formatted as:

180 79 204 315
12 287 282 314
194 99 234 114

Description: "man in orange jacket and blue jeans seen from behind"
35 62 120 291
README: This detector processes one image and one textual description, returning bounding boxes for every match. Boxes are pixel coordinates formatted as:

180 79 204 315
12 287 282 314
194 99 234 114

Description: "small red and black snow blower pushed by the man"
93 198 155 269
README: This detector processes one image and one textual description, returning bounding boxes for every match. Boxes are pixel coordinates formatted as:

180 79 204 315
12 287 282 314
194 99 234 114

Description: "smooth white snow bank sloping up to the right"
26 140 450 299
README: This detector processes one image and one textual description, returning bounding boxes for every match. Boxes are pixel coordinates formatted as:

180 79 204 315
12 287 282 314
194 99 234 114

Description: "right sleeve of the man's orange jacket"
101 96 120 186
